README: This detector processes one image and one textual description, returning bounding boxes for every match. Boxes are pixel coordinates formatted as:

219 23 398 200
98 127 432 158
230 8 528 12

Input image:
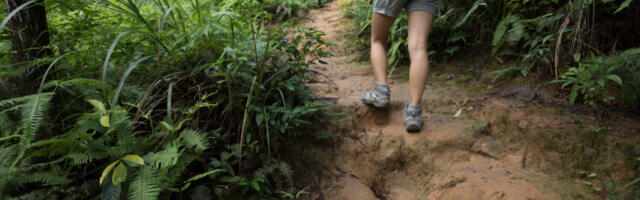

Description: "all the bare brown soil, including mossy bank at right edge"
294 1 640 200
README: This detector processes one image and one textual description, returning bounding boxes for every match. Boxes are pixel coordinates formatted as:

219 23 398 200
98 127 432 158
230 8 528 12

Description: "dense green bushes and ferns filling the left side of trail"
0 0 326 199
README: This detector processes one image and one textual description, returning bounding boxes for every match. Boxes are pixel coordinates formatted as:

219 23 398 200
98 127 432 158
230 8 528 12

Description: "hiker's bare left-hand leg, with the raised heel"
371 13 395 84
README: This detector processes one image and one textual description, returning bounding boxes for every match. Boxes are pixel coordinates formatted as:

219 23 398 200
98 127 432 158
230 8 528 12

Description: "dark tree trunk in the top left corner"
5 0 52 95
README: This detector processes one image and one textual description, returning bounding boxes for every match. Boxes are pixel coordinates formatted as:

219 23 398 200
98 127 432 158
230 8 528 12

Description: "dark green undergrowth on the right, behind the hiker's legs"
344 0 640 109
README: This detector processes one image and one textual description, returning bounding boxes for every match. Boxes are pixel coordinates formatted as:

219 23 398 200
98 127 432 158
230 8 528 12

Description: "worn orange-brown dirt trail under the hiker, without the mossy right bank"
301 1 636 200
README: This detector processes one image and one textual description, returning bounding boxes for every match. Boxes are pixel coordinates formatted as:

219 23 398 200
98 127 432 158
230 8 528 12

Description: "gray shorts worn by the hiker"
373 0 440 17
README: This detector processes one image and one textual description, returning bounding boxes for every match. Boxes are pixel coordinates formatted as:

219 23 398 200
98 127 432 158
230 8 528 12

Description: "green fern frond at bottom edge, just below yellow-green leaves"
129 167 161 200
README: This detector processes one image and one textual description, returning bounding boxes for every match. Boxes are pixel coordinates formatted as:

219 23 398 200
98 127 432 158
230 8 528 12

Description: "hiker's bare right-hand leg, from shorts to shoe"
408 11 433 105
